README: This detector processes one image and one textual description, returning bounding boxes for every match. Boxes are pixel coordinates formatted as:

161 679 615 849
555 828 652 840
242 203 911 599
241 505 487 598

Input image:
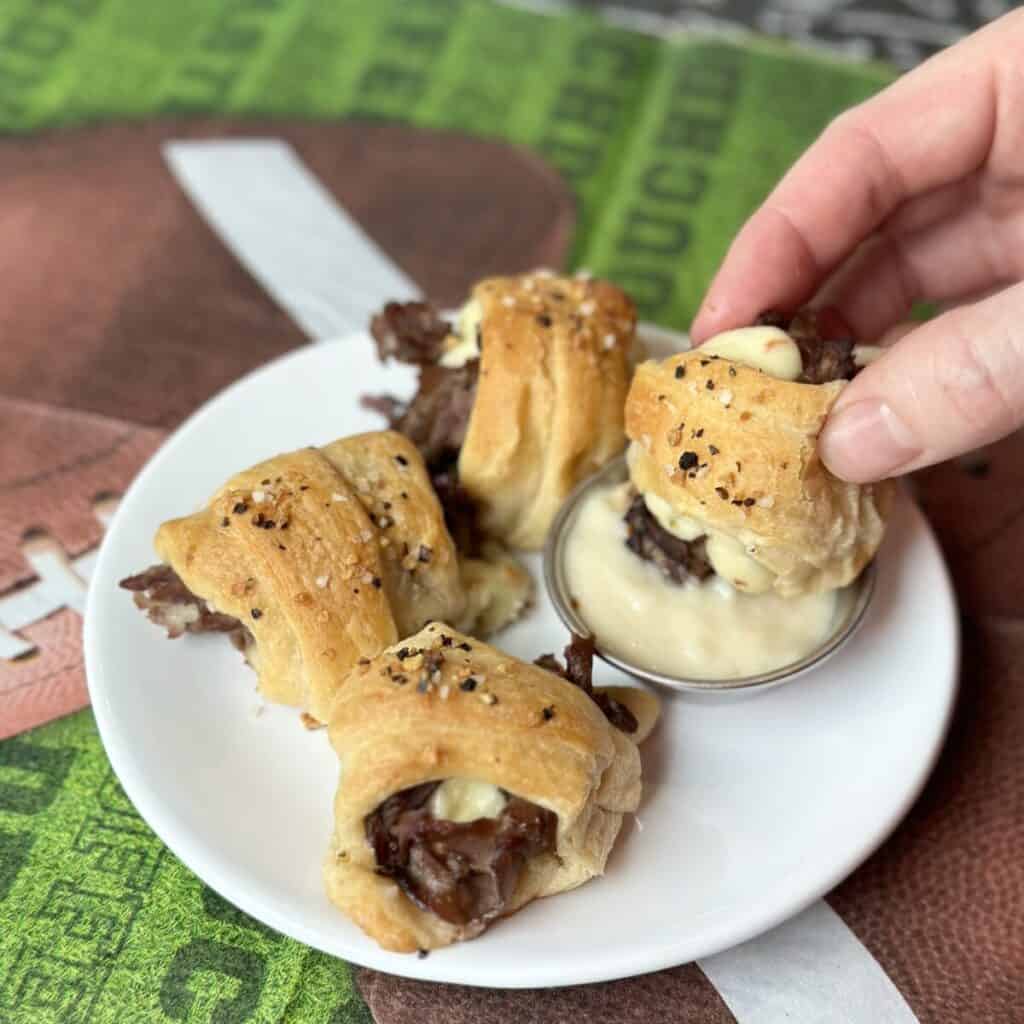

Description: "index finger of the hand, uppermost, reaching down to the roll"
691 11 1024 342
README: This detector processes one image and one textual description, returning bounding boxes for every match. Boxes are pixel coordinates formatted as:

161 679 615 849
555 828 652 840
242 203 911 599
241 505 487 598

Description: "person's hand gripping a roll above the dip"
691 10 1024 482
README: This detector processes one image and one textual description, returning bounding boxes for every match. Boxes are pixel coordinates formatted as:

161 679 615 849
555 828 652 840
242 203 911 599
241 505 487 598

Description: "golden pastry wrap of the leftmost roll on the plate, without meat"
156 431 466 721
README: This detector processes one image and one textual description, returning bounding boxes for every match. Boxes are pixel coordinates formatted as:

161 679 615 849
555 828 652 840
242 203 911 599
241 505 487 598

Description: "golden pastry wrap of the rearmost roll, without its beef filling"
459 273 636 550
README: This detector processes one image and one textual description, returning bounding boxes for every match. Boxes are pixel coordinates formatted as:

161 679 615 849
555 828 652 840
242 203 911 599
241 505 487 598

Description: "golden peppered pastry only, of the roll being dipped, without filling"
626 349 893 596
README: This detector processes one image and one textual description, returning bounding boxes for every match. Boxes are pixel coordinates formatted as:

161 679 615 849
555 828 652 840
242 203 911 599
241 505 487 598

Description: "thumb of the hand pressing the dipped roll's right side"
818 285 1024 483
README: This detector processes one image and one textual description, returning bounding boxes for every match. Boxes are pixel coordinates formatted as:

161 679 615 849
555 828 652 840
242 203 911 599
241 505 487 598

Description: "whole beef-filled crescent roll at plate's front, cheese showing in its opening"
324 624 657 952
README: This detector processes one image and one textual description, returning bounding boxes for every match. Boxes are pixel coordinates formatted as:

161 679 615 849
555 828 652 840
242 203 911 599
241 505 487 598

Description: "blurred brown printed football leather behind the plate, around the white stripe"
0 120 574 427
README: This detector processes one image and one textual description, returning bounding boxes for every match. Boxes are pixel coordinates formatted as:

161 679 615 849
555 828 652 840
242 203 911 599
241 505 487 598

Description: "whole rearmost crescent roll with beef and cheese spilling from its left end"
371 271 636 550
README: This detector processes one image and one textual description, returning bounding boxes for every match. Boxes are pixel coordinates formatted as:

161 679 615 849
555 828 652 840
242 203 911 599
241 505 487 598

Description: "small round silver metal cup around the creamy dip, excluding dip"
544 456 876 693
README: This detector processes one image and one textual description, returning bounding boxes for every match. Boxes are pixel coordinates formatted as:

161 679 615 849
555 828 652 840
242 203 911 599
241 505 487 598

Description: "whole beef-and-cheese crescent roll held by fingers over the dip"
626 314 893 597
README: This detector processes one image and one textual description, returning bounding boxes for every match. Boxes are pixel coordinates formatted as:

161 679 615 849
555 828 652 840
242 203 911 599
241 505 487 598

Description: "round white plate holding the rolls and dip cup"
85 335 957 987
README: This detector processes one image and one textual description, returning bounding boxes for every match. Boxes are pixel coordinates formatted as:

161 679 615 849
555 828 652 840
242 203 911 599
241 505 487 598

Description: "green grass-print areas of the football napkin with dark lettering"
0 0 888 1024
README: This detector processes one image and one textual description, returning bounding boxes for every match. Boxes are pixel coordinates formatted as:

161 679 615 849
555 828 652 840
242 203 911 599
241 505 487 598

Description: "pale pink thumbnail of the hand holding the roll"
818 398 923 483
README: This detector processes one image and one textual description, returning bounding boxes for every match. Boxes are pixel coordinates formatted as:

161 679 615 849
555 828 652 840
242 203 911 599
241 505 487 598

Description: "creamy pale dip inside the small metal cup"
564 485 839 679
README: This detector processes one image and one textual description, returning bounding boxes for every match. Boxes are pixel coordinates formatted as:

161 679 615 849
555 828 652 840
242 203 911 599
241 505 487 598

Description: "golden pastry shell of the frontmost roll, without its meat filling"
325 624 653 952
